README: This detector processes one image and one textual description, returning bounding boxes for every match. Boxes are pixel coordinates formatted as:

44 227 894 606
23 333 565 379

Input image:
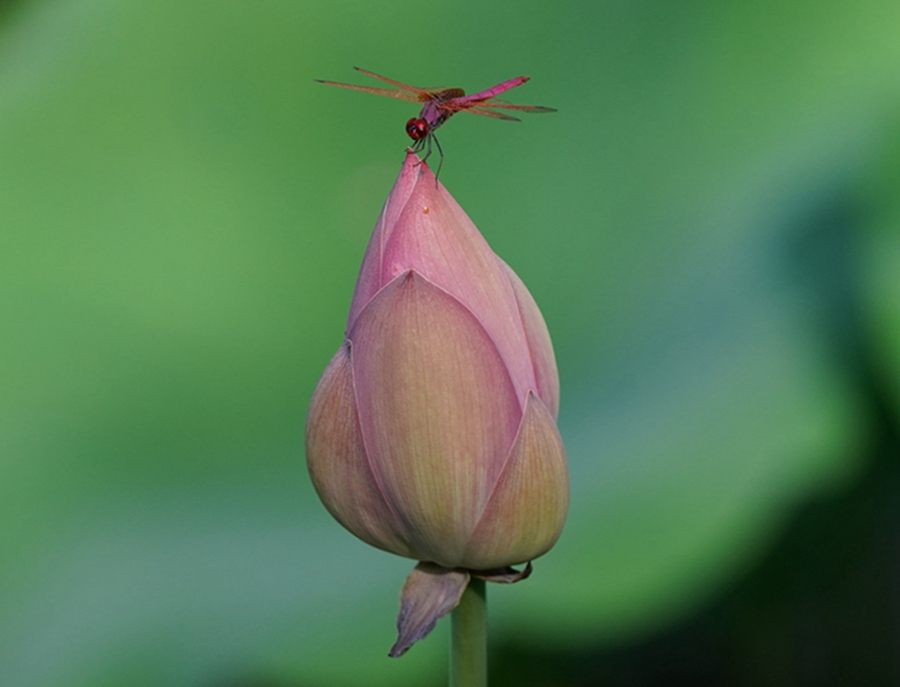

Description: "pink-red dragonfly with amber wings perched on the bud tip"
315 67 556 176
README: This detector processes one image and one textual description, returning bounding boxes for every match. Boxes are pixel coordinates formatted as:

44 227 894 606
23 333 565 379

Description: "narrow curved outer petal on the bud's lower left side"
306 344 414 556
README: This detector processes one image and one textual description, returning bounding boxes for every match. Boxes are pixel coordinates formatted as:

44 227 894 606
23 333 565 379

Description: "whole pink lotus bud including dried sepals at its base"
306 151 568 655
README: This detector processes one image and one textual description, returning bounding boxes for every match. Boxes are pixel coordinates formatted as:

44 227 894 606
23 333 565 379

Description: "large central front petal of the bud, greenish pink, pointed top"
350 271 521 568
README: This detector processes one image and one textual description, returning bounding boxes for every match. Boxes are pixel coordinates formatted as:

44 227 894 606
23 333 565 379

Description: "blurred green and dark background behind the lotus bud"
0 0 900 687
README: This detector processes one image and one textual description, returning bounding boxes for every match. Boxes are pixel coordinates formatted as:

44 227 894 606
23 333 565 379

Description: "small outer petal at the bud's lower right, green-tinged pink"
463 394 569 570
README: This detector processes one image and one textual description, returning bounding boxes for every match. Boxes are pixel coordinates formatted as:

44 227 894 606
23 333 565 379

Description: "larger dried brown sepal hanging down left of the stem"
388 563 469 658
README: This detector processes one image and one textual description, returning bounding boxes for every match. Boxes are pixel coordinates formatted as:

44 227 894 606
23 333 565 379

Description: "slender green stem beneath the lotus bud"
450 577 487 687
